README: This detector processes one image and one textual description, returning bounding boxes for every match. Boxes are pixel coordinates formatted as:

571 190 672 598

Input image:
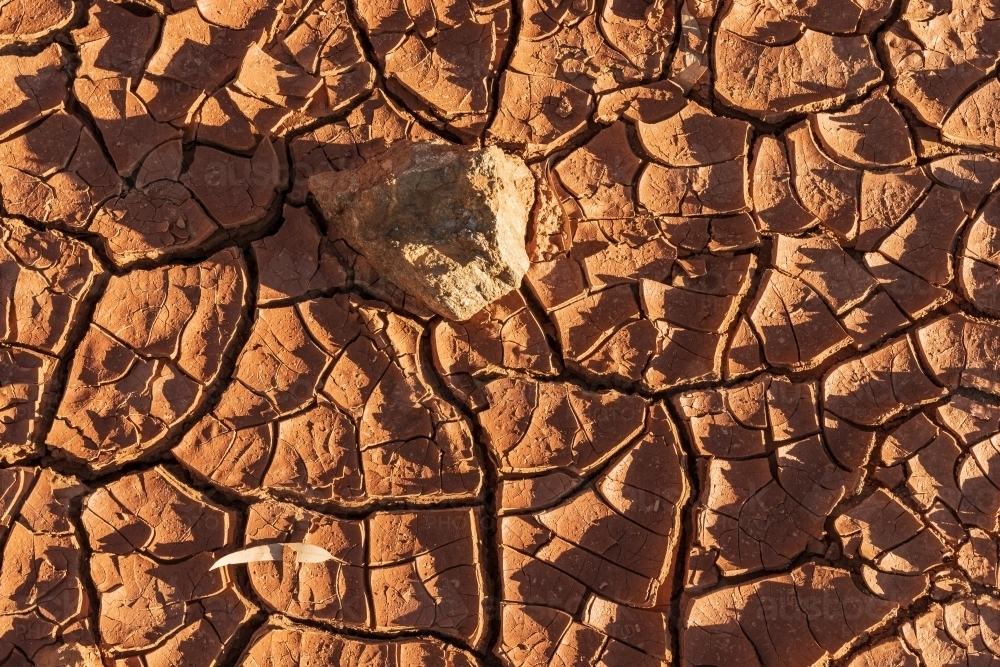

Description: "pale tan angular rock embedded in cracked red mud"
309 143 535 320
